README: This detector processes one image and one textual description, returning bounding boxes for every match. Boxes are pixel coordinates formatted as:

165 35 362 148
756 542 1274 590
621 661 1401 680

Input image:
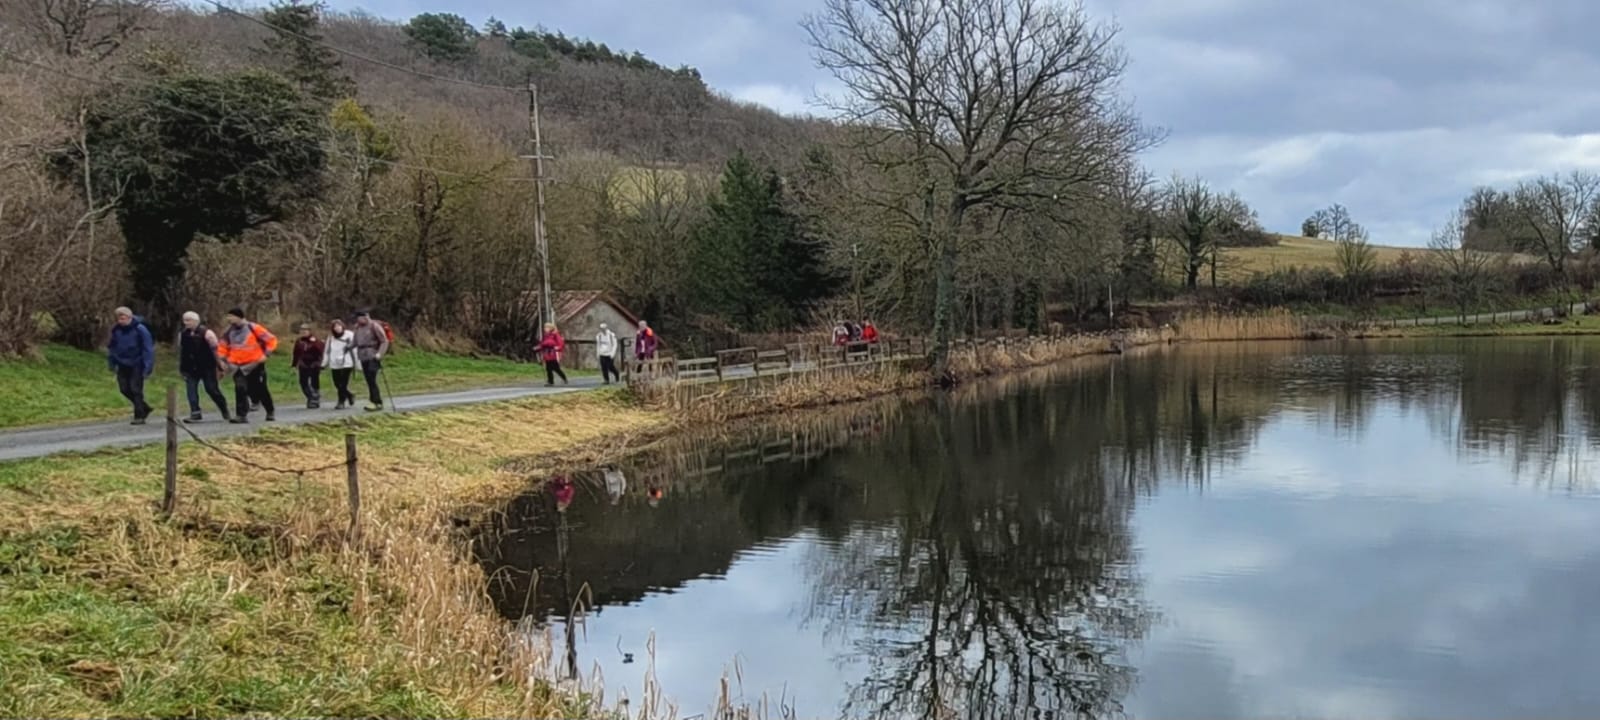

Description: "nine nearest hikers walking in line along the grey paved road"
106 307 661 426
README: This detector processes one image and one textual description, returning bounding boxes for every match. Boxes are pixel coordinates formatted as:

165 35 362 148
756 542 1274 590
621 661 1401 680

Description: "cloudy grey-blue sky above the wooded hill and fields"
330 0 1600 246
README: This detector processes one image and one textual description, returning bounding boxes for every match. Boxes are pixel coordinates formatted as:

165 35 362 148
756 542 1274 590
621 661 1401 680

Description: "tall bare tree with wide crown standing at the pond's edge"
805 0 1150 374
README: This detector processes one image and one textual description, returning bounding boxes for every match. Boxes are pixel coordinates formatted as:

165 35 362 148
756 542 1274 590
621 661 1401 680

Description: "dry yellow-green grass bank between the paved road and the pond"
0 392 666 717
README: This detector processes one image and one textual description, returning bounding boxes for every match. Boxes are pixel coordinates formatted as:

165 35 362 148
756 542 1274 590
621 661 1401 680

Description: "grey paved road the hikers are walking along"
0 378 600 462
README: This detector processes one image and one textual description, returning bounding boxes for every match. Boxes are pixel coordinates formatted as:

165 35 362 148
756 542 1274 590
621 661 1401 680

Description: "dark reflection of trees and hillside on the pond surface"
478 342 1600 718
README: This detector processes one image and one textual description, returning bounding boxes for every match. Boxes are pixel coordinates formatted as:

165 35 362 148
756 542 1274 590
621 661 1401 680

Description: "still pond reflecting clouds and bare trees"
482 339 1600 718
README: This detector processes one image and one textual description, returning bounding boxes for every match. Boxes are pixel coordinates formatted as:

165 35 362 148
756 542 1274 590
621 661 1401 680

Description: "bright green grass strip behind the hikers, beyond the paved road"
0 338 592 427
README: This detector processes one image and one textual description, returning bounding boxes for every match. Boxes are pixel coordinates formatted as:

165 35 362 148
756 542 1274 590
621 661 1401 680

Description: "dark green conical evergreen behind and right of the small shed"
690 152 835 330
